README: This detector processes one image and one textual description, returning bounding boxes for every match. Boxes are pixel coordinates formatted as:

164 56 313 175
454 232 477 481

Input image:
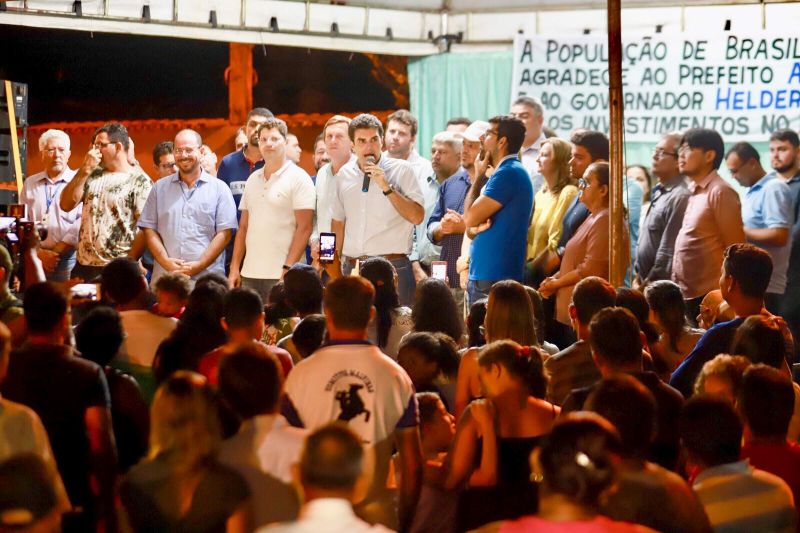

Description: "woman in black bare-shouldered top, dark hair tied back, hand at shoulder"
445 340 560 531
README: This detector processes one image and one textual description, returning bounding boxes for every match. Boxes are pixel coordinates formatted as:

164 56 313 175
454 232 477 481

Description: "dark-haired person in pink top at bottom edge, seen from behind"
500 412 653 533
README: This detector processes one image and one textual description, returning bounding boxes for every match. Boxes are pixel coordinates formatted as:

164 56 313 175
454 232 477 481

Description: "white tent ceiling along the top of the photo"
0 0 800 56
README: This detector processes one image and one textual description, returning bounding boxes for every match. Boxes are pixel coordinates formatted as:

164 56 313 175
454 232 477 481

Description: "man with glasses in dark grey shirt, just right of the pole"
633 133 691 290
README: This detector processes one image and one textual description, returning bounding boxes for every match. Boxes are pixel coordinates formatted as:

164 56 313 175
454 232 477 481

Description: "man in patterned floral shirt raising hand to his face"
59 122 153 281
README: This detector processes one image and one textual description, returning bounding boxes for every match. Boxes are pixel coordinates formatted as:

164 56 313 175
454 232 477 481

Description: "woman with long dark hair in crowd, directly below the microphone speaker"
359 257 414 359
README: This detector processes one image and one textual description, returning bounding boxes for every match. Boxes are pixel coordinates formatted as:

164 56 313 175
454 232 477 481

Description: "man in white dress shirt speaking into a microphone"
331 114 425 305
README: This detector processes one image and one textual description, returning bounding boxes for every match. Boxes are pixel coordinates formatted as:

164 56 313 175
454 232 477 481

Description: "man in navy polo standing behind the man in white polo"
217 107 274 273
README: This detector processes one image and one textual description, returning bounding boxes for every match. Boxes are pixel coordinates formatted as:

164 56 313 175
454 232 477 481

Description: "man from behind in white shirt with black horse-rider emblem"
281 276 422 531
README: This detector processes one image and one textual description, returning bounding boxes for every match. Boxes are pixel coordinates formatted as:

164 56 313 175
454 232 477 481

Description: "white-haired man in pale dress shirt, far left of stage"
20 130 83 281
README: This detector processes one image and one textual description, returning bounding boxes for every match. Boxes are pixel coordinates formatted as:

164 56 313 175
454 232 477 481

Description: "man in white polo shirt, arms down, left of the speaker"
228 118 316 301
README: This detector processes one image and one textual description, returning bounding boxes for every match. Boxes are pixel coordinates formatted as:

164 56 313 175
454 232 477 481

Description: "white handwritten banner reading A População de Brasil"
511 32 800 142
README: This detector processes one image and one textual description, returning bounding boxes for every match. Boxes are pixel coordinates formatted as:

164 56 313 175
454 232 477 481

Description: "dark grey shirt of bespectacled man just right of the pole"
636 176 691 282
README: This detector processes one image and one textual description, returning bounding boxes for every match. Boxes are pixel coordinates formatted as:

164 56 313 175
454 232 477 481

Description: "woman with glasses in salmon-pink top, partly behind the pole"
539 163 630 326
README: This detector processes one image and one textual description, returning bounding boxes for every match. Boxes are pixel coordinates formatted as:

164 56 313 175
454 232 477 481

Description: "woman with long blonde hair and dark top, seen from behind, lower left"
120 371 251 533
